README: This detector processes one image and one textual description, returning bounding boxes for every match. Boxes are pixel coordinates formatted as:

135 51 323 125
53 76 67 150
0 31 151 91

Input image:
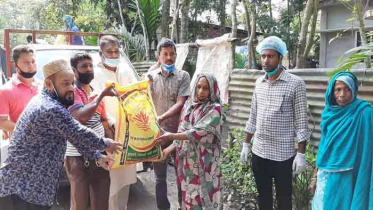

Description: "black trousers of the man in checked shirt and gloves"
251 154 294 210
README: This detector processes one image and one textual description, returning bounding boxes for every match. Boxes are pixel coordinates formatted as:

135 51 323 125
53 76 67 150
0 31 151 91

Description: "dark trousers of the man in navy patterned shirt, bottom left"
0 195 52 210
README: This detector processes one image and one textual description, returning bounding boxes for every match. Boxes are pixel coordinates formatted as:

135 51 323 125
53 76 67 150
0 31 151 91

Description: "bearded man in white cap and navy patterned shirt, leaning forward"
0 60 121 210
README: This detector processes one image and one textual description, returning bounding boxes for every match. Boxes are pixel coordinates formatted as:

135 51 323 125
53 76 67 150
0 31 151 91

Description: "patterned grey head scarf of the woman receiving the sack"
179 74 222 139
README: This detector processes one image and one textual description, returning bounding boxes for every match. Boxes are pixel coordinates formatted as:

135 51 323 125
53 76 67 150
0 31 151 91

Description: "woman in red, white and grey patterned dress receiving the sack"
157 74 222 210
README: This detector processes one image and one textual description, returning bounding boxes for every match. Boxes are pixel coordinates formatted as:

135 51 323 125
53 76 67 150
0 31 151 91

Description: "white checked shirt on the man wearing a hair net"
245 70 309 161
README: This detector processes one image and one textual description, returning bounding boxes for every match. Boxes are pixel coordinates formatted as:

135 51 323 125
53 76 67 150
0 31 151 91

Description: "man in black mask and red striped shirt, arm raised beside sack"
65 53 115 210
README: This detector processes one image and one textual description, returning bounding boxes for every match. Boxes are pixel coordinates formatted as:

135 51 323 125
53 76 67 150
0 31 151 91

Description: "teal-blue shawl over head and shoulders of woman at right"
316 72 373 171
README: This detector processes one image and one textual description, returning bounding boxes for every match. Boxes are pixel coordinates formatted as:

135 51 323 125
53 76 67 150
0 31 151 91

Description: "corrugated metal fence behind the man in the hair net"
226 69 373 145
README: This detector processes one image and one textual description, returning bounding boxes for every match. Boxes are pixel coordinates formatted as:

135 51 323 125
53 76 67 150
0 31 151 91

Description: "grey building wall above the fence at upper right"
320 4 373 68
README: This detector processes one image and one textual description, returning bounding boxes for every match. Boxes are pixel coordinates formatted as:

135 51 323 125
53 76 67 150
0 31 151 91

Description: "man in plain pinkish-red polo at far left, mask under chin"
0 45 42 137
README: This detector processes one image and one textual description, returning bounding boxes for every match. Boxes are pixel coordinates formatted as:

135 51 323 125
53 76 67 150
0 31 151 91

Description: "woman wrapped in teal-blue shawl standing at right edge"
312 72 373 210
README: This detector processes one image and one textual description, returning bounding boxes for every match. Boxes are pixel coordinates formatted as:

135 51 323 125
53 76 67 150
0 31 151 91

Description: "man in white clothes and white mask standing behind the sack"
91 35 138 210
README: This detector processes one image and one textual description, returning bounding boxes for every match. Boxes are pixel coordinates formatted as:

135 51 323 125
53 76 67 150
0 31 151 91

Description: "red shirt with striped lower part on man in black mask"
66 81 107 156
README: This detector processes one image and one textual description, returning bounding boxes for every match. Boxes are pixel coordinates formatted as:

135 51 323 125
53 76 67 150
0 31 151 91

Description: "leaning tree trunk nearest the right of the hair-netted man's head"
296 0 315 68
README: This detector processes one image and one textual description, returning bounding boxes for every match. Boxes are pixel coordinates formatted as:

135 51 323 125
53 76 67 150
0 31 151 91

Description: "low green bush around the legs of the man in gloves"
222 129 316 210
